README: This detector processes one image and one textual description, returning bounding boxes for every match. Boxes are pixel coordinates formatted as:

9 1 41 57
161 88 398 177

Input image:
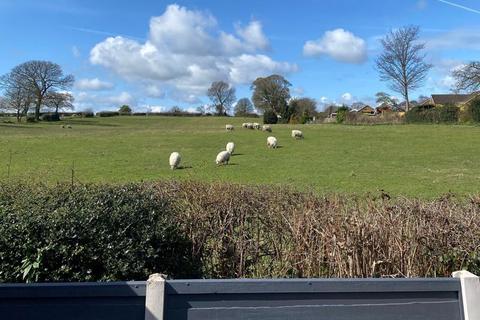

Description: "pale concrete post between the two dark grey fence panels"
145 273 166 320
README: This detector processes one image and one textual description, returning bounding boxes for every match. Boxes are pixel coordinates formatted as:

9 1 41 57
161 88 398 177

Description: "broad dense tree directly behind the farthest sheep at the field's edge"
251 74 292 120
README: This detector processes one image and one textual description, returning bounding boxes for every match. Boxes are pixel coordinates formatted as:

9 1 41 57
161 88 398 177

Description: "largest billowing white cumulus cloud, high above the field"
90 4 297 103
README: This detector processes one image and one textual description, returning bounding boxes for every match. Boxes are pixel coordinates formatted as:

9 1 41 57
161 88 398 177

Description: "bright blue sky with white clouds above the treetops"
0 0 480 111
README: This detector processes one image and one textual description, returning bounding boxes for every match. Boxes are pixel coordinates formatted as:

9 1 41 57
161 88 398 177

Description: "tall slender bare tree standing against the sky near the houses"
376 26 432 111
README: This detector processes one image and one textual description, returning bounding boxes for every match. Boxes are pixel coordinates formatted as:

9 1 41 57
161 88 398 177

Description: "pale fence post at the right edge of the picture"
452 270 480 320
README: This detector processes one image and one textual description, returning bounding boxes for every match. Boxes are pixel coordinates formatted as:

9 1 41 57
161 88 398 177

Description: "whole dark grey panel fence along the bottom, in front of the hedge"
0 272 480 320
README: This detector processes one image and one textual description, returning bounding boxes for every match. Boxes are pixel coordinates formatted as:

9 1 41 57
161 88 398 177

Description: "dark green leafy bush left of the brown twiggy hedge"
0 184 198 282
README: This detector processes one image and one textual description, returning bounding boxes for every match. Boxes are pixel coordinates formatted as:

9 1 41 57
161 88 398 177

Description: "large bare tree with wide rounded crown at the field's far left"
2 60 74 120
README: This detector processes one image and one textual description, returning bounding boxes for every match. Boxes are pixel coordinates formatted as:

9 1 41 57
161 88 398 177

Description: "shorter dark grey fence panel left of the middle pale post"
0 282 145 320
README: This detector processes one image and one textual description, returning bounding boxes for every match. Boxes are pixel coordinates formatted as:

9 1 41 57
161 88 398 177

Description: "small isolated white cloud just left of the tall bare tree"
303 29 367 63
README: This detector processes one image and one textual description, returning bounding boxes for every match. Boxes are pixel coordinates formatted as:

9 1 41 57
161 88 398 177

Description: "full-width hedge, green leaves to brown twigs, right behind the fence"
0 182 480 282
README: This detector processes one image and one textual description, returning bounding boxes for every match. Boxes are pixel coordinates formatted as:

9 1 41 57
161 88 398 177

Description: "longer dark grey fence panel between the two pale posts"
165 279 463 320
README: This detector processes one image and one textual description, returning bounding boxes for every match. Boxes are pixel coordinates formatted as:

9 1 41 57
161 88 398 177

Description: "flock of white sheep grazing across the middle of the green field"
169 122 303 170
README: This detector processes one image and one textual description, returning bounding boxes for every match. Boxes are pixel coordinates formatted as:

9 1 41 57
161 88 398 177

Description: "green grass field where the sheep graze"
0 117 480 198
